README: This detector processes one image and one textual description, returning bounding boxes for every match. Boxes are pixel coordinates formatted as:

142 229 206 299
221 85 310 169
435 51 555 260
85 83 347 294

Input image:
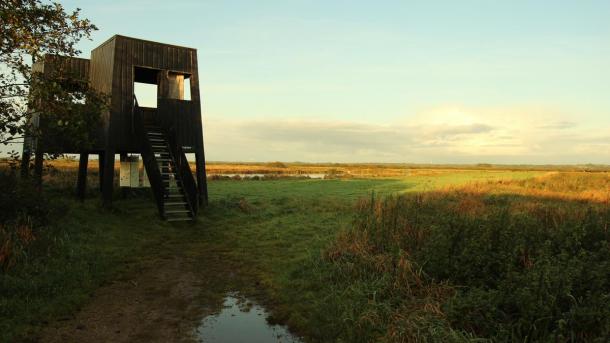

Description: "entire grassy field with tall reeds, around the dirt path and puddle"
0 168 610 342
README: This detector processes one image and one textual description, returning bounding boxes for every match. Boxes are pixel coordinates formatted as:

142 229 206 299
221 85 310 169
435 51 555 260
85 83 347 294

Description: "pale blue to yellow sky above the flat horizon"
14 0 610 164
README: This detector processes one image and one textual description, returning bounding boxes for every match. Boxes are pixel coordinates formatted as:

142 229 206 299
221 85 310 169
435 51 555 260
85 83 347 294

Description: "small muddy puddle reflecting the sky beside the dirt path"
195 293 302 343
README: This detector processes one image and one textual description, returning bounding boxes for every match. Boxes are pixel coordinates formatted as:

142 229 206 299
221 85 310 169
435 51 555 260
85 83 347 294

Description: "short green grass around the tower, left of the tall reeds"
0 171 540 341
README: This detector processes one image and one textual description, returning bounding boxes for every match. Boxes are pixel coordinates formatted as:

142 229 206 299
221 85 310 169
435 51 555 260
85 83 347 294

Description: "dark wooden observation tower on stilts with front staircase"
24 35 207 220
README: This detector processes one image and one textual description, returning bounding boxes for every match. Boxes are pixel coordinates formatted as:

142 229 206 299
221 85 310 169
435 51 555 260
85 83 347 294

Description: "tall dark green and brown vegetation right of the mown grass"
320 174 610 342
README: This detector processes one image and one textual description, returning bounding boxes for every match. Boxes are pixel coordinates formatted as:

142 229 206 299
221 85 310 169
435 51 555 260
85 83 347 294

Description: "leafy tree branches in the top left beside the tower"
0 0 100 155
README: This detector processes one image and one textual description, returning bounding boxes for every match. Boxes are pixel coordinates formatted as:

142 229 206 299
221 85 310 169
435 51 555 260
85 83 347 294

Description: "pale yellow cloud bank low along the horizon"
205 107 610 163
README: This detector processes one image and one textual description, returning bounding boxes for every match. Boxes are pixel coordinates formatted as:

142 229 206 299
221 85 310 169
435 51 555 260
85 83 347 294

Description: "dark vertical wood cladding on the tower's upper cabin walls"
32 35 203 153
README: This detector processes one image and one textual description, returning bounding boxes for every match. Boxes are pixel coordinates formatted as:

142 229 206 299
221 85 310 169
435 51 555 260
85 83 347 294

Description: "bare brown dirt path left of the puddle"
40 257 220 342
